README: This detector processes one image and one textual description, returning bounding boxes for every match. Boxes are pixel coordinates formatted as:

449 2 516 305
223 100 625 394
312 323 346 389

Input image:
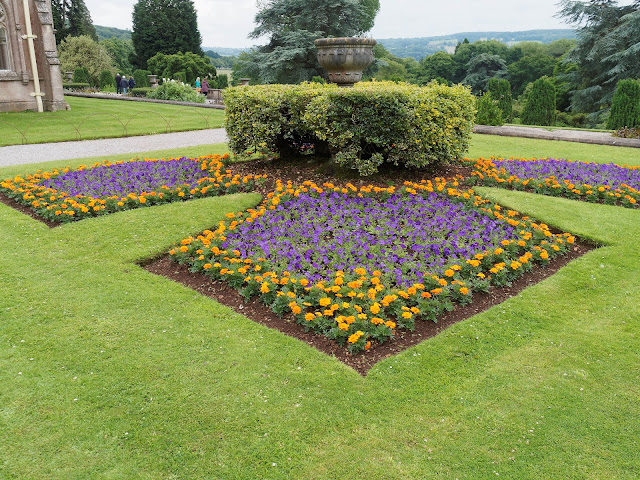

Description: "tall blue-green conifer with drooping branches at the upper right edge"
559 0 640 115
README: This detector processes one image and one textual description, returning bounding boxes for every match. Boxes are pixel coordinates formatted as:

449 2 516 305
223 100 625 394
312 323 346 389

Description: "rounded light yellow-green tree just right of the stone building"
58 35 113 85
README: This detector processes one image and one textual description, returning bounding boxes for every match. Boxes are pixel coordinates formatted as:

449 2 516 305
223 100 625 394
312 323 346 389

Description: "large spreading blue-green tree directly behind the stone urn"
234 0 379 83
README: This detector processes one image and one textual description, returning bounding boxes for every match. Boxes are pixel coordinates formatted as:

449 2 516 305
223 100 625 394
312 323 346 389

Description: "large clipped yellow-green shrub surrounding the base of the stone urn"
224 82 475 175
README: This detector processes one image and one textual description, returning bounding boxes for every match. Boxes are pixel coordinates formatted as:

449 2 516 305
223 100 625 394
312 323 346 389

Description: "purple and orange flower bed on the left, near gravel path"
0 155 261 222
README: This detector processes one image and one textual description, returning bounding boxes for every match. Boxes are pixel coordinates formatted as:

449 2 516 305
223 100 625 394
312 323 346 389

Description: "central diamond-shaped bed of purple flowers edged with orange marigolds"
169 179 574 352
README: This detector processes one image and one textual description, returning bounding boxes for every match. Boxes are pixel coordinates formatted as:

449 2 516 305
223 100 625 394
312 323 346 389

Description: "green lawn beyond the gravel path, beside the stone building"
0 96 224 147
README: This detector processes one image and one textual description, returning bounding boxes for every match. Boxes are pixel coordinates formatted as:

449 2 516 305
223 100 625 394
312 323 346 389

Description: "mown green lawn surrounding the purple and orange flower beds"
0 135 640 480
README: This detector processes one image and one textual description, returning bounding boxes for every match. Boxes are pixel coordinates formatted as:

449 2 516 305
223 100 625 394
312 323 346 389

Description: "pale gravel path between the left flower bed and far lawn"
0 128 227 167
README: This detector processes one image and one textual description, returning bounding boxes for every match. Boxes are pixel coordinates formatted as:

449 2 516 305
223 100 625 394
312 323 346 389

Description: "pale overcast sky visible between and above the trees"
85 0 630 48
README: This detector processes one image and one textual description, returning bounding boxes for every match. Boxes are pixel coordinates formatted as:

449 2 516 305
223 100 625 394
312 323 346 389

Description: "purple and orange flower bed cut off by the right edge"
466 158 640 208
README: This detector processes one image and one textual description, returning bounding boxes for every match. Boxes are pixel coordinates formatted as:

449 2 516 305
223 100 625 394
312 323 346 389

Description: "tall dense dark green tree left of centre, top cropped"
130 0 204 69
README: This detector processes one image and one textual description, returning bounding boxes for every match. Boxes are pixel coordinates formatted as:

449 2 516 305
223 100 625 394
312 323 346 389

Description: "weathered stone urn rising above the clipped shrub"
315 37 376 87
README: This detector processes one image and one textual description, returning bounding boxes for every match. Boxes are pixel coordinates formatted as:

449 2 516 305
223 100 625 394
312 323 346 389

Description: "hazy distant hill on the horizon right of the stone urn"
376 29 576 60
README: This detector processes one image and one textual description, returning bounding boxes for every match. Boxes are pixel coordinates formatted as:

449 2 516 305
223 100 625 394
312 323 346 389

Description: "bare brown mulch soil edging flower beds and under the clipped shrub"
0 157 592 375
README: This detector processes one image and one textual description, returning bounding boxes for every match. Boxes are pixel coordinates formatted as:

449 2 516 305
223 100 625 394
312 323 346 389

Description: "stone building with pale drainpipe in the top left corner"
0 0 68 112
